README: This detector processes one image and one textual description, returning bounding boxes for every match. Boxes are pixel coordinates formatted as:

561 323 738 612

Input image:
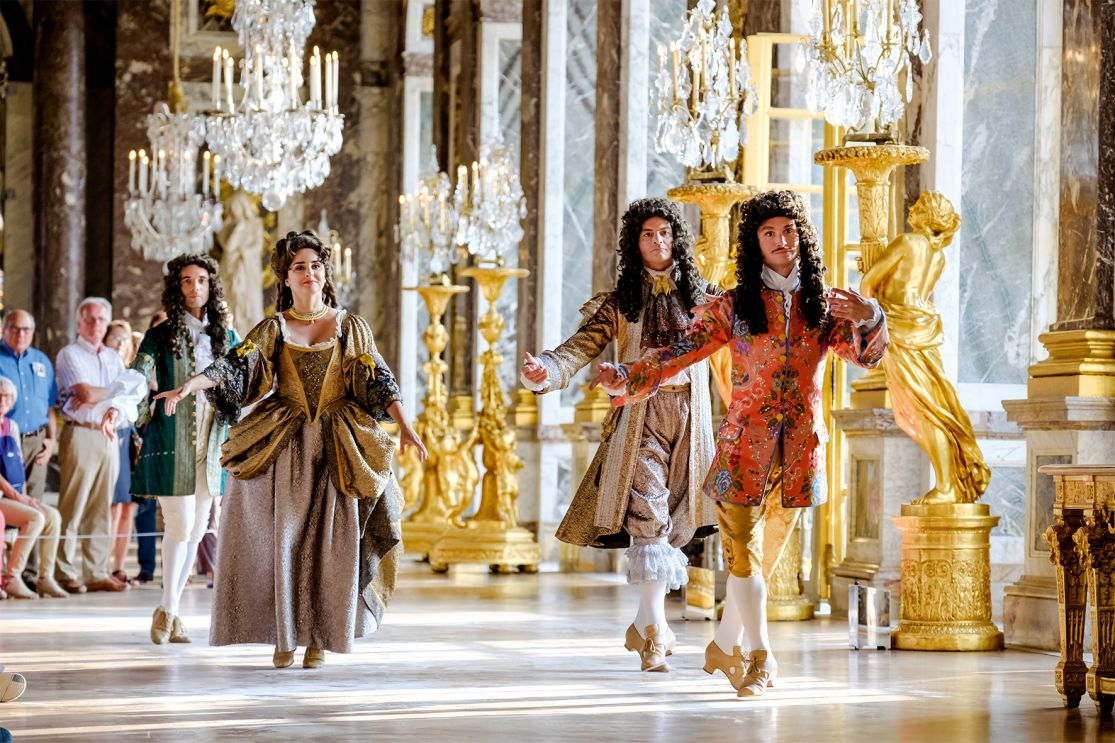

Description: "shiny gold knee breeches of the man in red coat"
716 450 802 579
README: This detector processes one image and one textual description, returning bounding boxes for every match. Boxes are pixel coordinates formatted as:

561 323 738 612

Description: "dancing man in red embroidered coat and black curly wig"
593 191 888 697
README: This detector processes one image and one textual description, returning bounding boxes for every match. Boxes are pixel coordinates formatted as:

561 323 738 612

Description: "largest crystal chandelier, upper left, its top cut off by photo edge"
205 0 345 211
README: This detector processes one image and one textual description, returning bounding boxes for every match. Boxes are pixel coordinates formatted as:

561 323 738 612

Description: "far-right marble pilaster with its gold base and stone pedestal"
1004 0 1115 649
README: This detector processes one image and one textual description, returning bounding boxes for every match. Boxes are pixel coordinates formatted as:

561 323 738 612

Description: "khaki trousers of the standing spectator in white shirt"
54 424 120 582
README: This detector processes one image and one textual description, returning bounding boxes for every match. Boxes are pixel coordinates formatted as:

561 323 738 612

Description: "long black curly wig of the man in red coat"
731 191 828 335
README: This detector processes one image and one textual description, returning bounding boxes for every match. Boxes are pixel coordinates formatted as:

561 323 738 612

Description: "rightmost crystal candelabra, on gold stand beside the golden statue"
803 0 931 142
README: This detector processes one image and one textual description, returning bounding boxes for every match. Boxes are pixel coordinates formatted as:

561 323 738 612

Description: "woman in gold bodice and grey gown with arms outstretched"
158 232 426 668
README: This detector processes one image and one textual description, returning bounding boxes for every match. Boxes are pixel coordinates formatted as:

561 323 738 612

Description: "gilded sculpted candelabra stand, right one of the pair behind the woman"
429 259 542 572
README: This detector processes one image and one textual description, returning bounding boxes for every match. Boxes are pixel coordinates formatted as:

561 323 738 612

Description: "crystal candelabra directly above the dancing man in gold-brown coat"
653 0 756 174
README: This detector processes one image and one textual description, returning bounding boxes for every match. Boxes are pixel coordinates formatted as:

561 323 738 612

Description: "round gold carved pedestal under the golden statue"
893 503 1002 650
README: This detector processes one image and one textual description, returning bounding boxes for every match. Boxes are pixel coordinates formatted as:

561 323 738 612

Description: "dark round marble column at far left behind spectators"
33 2 87 357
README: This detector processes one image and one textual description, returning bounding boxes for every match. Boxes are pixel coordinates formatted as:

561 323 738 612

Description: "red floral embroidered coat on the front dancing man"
612 287 889 508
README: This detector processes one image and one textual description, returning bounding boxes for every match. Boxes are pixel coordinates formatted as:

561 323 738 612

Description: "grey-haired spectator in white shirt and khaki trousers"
55 297 147 594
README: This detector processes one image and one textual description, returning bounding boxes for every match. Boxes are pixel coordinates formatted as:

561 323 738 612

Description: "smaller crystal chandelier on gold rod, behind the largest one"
124 0 222 262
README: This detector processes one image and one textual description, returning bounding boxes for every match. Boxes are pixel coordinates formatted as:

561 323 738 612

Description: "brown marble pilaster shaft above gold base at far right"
1057 0 1099 327
